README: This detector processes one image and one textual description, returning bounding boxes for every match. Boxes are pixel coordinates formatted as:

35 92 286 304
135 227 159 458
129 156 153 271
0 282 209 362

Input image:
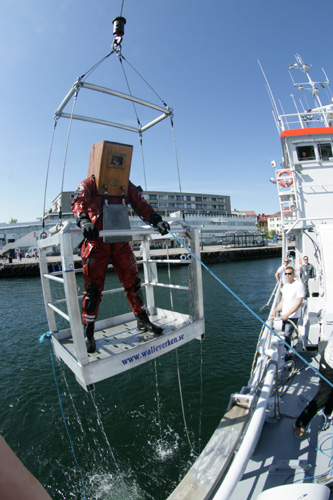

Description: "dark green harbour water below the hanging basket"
0 259 280 500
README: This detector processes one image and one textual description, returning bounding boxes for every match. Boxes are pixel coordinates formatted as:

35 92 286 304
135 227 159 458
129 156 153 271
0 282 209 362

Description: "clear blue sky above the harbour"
0 0 333 222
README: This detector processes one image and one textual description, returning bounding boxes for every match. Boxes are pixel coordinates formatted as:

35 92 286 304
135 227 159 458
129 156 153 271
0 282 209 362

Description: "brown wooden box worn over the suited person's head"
88 141 133 196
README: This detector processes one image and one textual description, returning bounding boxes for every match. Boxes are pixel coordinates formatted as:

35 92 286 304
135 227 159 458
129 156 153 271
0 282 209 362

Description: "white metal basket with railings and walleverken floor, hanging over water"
38 221 204 390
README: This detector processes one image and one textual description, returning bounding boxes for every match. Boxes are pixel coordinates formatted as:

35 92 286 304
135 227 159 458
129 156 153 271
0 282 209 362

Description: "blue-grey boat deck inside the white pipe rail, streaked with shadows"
230 352 333 500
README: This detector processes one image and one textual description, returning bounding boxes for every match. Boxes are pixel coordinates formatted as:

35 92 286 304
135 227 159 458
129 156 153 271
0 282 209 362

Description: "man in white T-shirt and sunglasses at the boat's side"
271 266 305 345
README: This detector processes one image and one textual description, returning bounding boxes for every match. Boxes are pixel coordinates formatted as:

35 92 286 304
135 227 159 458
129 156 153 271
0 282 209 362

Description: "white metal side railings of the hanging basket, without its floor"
38 221 203 366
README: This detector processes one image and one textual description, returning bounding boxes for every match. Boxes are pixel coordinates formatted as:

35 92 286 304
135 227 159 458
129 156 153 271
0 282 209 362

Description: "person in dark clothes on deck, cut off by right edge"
295 336 333 439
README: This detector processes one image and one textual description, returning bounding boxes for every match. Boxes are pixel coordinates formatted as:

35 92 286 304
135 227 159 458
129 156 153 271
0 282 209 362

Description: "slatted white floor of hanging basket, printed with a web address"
52 309 204 389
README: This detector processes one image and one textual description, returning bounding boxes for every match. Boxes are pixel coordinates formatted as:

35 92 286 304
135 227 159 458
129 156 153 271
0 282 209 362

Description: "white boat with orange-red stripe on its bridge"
169 55 333 500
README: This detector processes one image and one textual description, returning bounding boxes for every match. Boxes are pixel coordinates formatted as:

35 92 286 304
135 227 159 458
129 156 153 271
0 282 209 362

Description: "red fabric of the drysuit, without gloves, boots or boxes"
72 176 156 325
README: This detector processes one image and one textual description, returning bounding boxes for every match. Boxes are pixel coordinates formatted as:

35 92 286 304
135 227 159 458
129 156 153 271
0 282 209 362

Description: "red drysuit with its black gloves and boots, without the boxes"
72 175 170 353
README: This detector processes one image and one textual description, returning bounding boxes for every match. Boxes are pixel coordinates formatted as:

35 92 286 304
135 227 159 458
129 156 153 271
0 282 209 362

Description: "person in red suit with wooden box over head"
72 141 170 353
